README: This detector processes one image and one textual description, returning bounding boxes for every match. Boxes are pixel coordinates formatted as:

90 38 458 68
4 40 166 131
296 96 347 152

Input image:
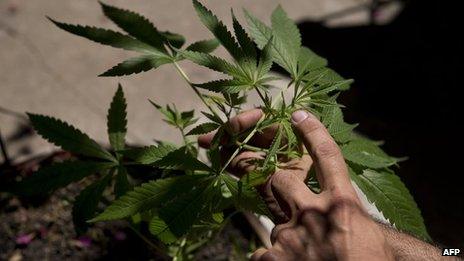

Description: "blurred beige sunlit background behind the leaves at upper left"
0 0 376 160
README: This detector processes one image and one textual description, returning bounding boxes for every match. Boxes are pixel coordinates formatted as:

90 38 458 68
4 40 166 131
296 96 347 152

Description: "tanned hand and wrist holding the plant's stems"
198 109 451 260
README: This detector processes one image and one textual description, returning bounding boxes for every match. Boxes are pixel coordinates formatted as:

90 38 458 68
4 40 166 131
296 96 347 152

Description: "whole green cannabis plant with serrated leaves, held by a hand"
16 0 429 255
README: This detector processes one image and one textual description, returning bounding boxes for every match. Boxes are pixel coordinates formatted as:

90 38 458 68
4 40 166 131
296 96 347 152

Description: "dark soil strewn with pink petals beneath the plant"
0 153 251 261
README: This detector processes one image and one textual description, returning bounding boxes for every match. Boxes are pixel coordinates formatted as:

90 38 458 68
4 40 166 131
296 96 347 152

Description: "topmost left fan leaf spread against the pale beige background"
48 3 219 76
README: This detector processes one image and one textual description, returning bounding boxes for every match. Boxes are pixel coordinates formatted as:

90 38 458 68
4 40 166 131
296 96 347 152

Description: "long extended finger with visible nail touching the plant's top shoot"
292 110 352 190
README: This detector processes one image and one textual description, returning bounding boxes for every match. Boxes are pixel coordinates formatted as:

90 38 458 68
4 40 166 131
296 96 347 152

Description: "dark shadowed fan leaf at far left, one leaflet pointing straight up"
18 85 132 233
